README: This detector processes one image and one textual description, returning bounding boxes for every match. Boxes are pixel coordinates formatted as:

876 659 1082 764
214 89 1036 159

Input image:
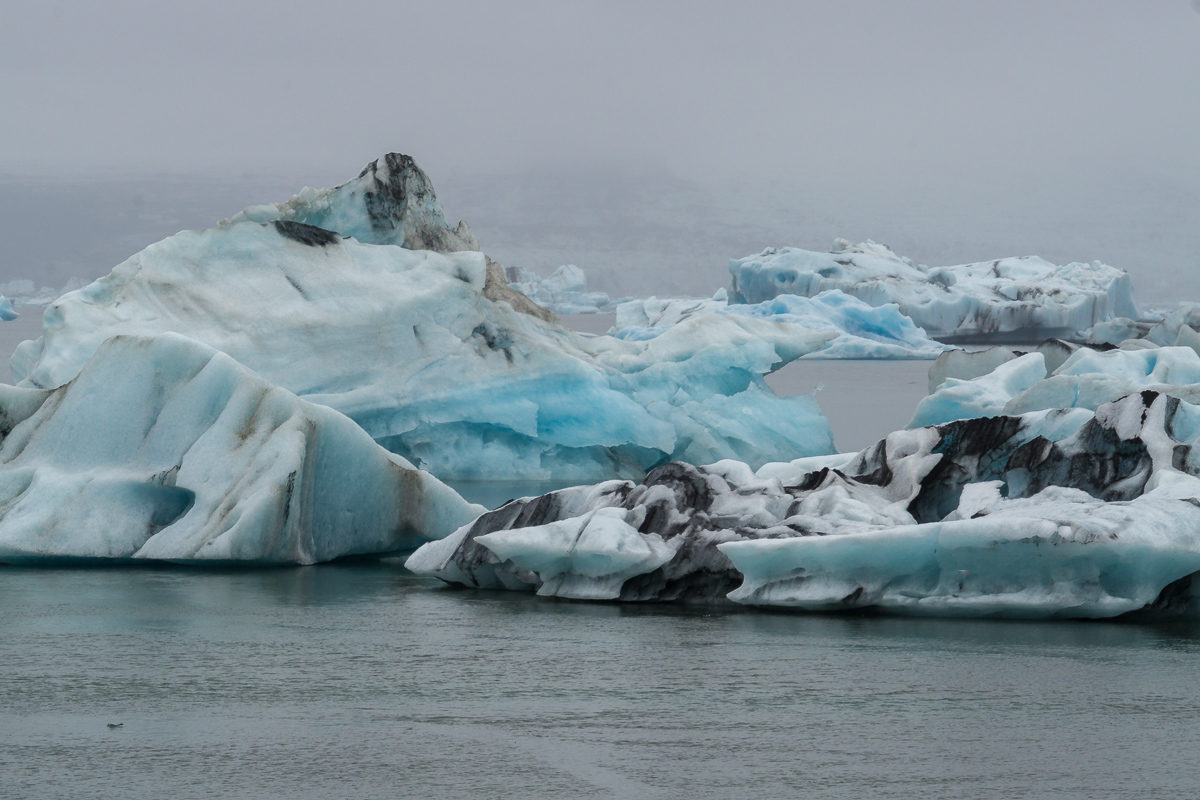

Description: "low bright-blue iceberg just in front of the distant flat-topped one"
611 289 948 359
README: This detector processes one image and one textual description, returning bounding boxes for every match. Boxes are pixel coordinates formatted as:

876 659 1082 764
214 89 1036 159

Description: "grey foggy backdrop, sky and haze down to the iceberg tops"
0 0 1200 301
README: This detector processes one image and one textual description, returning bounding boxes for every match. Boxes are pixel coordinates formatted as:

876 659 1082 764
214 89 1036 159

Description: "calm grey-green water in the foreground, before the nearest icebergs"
0 563 1200 799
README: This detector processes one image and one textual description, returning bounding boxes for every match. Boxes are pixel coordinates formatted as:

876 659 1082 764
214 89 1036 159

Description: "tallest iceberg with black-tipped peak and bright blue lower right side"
12 155 833 481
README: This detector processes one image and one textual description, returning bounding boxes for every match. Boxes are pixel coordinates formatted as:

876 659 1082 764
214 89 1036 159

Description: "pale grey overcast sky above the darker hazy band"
0 0 1200 181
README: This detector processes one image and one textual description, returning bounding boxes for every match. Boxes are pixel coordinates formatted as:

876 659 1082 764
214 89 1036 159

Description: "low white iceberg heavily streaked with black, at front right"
407 391 1200 618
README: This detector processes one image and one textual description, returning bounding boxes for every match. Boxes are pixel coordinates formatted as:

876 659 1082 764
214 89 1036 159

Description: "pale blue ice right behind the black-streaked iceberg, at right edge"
908 347 1200 428
